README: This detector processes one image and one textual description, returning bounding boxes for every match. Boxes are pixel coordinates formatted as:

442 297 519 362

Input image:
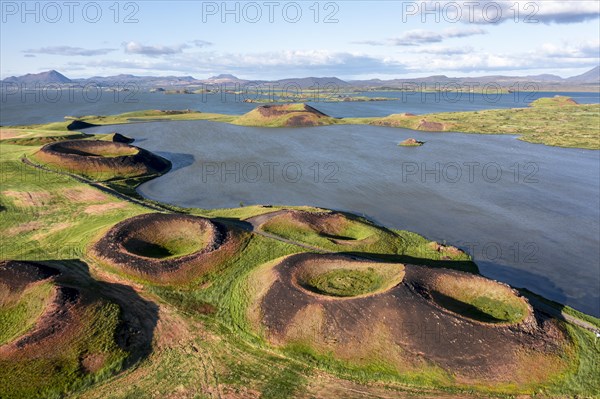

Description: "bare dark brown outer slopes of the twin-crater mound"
260 253 568 382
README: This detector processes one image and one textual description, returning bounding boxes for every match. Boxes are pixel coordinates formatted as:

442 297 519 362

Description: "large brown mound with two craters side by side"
248 253 572 384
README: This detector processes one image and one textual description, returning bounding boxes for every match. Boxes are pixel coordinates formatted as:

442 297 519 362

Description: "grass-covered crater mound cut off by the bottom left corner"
0 261 128 399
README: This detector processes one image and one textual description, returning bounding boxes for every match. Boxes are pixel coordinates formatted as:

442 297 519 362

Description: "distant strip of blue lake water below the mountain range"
0 89 600 126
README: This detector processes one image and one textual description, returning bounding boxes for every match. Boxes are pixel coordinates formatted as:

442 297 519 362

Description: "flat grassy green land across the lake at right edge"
370 96 600 150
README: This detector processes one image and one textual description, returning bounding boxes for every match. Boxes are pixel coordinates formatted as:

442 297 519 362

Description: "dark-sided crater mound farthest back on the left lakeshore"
34 140 171 180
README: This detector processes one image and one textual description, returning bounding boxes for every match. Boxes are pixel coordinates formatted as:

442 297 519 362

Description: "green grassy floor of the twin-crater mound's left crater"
306 268 384 297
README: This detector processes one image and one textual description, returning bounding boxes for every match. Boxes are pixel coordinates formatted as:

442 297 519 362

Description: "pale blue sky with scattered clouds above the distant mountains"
0 0 600 79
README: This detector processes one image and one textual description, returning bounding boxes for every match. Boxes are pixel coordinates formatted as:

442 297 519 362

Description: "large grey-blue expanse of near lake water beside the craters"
83 122 600 316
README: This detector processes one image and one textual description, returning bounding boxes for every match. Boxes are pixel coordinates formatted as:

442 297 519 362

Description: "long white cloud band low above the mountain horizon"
59 41 600 79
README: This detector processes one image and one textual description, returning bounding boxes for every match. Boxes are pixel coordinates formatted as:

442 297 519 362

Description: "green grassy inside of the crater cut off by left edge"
0 282 53 345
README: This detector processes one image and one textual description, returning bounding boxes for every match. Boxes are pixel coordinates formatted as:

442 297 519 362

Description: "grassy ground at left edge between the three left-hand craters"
0 144 149 260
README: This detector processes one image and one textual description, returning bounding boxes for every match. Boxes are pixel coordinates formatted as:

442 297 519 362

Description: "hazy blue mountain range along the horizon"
0 66 600 89
